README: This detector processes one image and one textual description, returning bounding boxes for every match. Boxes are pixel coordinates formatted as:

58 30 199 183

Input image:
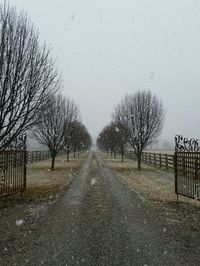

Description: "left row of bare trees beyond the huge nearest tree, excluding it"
32 94 91 170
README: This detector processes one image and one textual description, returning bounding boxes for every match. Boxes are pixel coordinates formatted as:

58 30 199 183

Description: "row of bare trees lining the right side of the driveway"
97 90 165 170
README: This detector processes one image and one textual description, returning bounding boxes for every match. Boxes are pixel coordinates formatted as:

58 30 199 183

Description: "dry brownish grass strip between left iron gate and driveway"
22 154 86 202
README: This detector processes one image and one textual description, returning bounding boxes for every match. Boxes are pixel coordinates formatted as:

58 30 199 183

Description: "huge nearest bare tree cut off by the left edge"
0 3 60 148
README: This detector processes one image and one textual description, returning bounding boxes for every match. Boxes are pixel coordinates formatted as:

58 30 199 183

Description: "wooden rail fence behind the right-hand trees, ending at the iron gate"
126 151 174 170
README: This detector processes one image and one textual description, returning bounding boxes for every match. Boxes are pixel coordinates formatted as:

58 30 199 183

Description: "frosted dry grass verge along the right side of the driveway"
102 154 200 231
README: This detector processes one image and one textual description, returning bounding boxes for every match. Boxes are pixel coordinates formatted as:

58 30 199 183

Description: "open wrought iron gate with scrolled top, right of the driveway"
175 136 200 200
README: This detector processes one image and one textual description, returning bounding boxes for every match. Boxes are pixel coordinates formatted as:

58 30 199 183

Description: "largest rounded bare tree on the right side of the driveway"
114 91 165 170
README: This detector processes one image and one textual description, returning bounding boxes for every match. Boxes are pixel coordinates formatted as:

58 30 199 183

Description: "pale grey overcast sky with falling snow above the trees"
10 0 200 145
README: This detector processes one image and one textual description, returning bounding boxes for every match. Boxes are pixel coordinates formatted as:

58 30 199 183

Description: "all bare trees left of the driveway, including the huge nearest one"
0 2 91 170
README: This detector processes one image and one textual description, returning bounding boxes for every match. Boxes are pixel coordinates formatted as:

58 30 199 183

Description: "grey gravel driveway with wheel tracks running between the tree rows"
0 152 200 266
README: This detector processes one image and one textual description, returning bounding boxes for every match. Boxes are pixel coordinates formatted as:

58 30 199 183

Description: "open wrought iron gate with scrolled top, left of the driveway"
0 136 27 197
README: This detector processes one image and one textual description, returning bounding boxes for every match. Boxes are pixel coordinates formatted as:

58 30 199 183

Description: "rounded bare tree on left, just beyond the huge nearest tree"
32 95 78 170
